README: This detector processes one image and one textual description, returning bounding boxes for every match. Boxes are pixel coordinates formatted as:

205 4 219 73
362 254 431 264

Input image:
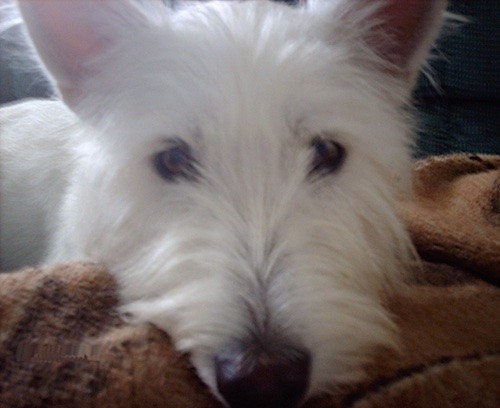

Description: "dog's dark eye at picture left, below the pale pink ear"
153 141 196 181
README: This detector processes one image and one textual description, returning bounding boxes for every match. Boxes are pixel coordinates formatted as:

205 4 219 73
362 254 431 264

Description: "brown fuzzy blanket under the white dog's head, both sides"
0 156 500 408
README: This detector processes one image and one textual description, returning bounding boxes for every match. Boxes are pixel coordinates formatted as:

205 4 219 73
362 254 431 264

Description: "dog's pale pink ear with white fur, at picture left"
18 0 148 108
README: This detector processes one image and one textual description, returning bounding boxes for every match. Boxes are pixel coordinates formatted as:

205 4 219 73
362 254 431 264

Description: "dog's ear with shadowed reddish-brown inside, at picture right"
306 0 447 88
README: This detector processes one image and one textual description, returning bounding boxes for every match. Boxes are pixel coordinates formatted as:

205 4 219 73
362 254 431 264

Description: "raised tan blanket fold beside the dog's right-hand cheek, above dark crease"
402 155 500 283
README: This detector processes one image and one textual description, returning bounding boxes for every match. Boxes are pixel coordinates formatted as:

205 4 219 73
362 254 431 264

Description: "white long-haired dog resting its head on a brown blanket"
0 0 445 407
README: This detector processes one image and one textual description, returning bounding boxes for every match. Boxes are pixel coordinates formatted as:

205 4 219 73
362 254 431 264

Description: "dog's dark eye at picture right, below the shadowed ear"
311 137 346 175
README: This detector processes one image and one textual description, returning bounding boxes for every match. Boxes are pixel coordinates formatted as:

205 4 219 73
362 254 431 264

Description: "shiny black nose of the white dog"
215 343 311 408
